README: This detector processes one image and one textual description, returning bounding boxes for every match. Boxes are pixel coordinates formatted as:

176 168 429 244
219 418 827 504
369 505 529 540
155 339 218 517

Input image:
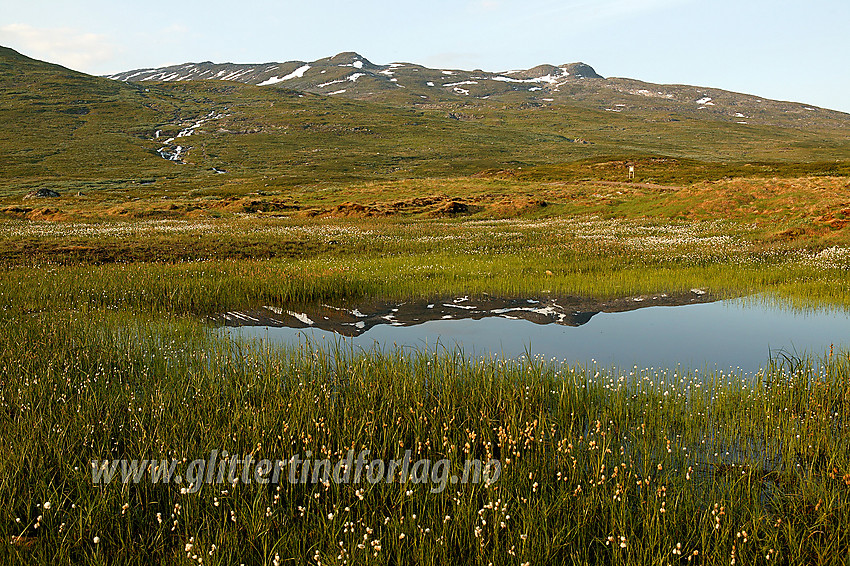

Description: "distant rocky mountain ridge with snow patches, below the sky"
109 52 850 128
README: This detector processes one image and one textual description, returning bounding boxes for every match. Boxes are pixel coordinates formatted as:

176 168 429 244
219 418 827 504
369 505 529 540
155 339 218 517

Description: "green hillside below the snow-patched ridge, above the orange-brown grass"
0 43 850 200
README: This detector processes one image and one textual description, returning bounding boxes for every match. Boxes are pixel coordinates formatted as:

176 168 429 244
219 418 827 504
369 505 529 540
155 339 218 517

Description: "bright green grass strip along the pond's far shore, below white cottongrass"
0 252 850 315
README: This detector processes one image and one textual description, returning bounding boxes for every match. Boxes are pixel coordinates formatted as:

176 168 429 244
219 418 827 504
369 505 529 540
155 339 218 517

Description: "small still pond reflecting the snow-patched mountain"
215 289 850 373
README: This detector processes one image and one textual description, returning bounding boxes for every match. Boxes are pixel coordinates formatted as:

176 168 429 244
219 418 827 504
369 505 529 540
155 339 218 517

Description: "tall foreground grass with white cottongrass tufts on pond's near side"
0 310 850 565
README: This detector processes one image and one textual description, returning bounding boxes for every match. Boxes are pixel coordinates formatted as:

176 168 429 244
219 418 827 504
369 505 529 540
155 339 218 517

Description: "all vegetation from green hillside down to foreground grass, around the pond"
0 45 850 566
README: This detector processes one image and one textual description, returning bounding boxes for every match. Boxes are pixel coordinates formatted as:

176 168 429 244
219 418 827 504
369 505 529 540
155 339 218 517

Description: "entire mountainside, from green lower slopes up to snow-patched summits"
0 44 850 196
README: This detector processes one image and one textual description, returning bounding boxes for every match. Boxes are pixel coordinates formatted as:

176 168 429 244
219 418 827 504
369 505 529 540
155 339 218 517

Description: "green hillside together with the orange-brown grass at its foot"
0 50 850 253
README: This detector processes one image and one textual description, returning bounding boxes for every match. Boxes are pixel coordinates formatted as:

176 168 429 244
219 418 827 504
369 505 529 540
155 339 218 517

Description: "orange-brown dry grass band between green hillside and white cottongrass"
0 177 850 246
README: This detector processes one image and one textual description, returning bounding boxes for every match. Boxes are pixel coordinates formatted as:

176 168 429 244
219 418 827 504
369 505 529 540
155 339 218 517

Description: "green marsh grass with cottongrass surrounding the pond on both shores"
0 218 850 565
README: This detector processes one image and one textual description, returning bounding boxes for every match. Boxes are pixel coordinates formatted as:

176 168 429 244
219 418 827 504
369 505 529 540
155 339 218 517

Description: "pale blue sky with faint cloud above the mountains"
0 0 850 112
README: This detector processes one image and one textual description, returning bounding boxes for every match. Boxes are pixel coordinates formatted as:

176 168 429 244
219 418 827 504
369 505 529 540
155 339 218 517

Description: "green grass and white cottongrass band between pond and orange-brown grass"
0 217 850 315
